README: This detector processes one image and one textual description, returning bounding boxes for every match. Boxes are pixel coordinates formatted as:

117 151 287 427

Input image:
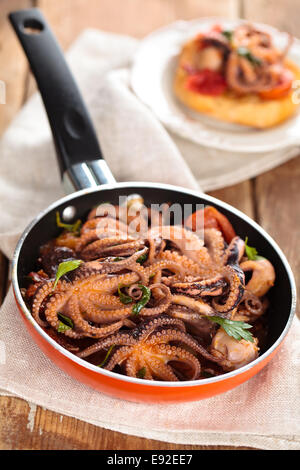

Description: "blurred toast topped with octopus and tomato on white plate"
174 23 300 128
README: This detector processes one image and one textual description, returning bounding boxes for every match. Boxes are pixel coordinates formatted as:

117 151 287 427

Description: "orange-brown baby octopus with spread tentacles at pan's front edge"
77 316 218 382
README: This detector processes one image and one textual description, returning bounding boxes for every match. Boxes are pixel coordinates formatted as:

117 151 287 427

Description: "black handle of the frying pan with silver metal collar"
9 8 115 190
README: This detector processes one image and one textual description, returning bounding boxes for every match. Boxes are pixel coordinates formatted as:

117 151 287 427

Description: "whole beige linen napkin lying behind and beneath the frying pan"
0 31 300 449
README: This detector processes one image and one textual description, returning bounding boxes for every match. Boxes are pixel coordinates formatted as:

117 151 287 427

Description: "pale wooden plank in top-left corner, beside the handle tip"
0 0 33 135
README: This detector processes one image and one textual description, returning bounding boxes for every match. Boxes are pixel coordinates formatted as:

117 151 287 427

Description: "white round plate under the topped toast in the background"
131 17 300 153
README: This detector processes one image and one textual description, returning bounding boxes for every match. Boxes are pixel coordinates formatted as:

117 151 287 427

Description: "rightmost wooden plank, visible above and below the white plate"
243 0 300 308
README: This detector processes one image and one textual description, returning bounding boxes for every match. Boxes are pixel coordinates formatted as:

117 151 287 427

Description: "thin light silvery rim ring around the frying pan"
12 181 296 388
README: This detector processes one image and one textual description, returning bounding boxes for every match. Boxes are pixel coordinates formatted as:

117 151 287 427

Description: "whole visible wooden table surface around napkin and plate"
0 0 300 450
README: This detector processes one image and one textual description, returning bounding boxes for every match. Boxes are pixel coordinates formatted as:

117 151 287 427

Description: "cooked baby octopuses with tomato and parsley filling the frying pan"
22 195 275 381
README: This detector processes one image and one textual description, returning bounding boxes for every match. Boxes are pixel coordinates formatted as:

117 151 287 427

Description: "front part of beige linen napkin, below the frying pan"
0 290 300 449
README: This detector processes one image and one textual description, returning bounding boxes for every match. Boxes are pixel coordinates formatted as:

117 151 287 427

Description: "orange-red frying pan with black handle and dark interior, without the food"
9 9 296 402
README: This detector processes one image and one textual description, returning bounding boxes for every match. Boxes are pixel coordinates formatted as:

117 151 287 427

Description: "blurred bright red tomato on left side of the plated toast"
186 69 227 96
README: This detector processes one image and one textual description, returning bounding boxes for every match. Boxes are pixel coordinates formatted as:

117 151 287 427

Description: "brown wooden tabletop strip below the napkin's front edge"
0 397 253 451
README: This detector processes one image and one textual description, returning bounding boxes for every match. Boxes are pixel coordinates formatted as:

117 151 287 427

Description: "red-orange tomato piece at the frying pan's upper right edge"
185 206 236 243
